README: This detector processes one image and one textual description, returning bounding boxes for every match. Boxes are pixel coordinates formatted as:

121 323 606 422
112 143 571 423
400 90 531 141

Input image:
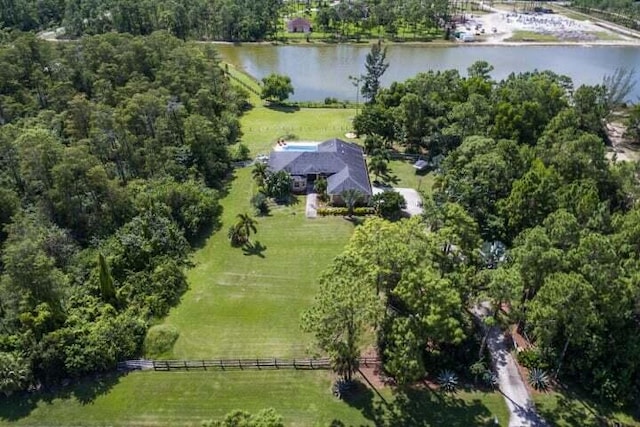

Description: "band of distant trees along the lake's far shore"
0 0 452 41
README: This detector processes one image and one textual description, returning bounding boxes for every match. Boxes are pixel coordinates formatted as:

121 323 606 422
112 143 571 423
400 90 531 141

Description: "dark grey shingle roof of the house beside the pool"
269 138 372 196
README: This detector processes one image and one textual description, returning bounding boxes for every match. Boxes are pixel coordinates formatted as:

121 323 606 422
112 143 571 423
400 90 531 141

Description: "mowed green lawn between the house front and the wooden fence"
165 168 353 359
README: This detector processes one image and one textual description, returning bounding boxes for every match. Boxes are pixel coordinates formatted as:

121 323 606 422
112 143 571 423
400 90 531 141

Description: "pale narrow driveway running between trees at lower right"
473 303 547 427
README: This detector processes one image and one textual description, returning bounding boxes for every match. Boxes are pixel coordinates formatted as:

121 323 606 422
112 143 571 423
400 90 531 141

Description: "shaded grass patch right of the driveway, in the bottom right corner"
533 392 640 427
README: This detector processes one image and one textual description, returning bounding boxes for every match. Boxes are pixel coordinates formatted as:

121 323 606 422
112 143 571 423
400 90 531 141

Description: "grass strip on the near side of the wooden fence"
0 371 508 427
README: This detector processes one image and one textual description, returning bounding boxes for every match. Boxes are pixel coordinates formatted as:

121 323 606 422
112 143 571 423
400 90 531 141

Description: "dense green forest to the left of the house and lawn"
0 32 246 394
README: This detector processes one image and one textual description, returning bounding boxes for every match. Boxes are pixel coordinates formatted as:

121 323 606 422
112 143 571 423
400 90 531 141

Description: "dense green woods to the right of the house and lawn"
303 62 640 407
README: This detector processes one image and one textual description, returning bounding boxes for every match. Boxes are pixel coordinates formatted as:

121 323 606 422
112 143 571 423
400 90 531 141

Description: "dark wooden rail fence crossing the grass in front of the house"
118 357 380 371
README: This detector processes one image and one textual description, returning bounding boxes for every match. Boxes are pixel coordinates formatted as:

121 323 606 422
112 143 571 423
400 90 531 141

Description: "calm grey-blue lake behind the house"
217 44 640 101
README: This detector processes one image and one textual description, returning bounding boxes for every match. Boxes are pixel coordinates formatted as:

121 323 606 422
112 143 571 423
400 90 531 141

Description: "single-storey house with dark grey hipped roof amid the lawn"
269 139 373 205
